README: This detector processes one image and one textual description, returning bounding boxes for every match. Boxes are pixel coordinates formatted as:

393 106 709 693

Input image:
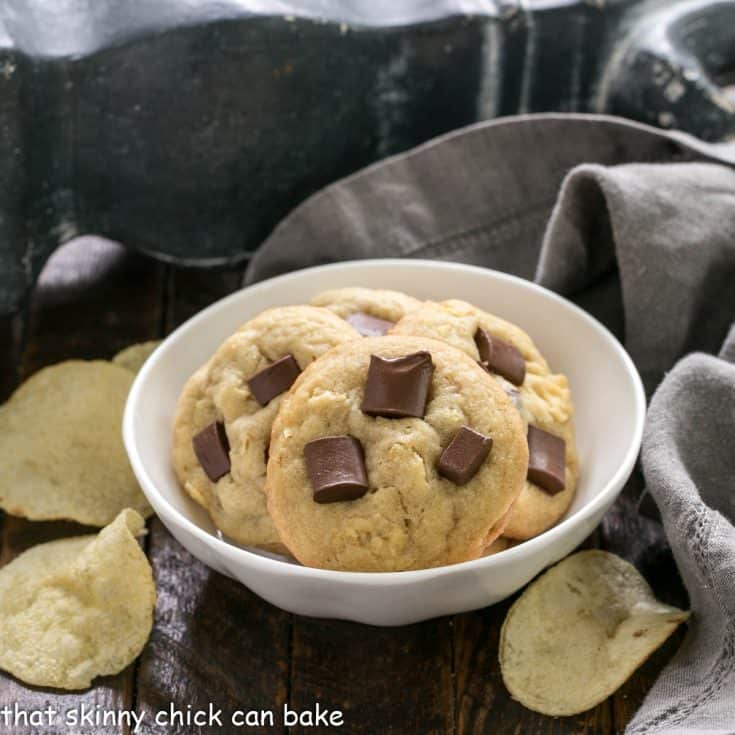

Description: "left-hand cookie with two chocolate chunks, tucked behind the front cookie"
173 306 360 553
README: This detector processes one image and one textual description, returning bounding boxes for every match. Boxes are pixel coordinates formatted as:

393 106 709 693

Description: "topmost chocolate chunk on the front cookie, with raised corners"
362 351 434 418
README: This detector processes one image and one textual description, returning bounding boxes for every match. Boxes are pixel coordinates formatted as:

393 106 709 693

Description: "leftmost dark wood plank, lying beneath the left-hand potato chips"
0 238 162 735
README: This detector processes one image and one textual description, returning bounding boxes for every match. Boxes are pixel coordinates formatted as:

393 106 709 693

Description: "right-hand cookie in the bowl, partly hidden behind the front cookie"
391 300 579 540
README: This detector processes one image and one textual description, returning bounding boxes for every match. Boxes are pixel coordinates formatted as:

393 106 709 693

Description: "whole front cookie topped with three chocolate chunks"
266 336 528 572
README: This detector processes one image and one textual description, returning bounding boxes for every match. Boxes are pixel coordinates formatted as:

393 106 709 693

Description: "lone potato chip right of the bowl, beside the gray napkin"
499 551 689 716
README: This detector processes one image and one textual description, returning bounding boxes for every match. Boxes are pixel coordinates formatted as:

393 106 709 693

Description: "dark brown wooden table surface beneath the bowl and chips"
0 238 686 735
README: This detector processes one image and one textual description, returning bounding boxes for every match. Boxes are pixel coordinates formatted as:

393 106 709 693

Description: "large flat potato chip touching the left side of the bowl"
0 360 152 526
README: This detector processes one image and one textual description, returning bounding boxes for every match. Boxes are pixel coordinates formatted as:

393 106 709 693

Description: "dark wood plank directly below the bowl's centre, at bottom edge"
290 617 454 735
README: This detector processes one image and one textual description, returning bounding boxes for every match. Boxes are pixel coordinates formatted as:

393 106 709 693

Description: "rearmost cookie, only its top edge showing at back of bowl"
311 287 421 337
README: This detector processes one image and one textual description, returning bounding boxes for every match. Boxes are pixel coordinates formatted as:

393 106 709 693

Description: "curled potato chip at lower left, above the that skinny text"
0 509 156 689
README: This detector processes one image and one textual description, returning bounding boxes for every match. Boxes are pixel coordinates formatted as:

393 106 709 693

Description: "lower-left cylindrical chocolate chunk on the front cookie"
304 436 368 503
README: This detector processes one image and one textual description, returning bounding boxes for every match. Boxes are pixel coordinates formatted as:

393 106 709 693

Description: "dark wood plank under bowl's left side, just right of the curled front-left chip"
137 269 289 733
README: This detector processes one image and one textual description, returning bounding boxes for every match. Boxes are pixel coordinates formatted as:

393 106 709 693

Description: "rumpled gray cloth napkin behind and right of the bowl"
246 115 735 735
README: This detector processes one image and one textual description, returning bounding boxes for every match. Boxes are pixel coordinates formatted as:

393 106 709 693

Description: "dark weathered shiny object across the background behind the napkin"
0 0 735 313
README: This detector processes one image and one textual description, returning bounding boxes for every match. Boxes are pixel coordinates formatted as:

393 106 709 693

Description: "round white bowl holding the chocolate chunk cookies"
123 260 645 625
